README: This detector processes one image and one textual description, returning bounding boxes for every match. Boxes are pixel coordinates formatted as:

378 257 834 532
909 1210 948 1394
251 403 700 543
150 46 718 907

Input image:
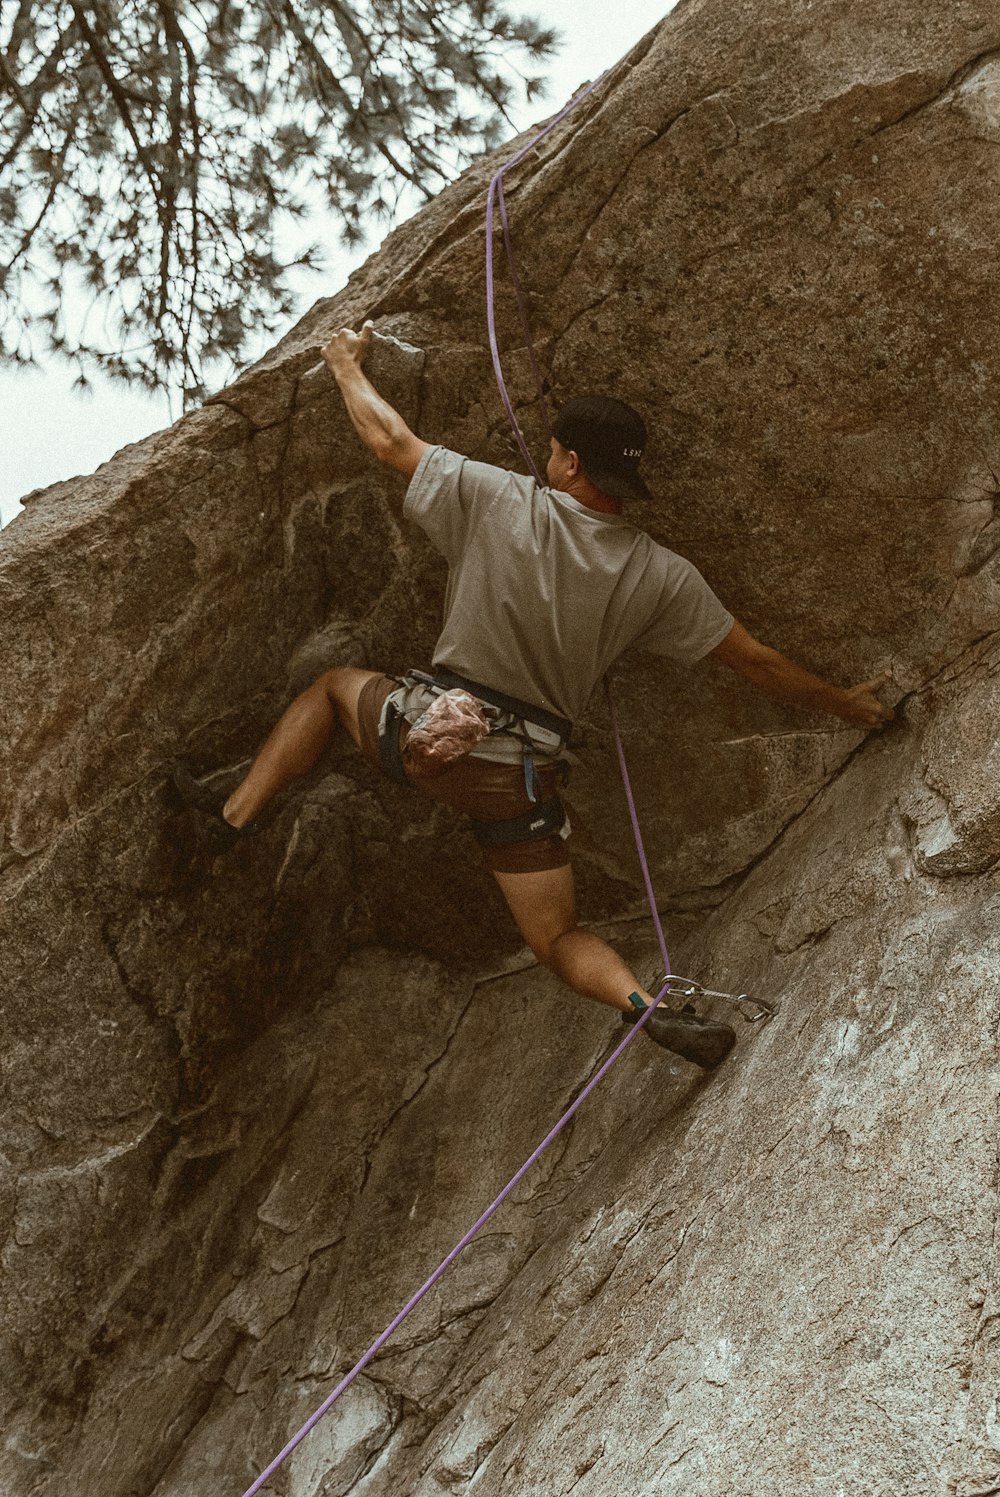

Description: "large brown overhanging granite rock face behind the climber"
0 0 1000 1497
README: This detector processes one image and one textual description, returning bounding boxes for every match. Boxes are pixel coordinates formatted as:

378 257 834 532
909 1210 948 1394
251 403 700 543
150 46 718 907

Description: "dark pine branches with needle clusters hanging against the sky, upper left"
0 0 555 403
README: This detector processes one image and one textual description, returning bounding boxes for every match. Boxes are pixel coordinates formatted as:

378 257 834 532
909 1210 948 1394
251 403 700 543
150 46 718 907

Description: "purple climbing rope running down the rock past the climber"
243 61 671 1497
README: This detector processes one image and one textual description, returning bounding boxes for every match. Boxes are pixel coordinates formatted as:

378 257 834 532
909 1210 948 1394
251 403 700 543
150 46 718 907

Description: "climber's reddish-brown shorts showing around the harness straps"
358 675 569 873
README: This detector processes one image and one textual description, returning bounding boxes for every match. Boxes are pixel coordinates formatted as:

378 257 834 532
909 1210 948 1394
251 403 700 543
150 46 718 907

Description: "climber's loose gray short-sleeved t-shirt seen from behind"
403 448 734 722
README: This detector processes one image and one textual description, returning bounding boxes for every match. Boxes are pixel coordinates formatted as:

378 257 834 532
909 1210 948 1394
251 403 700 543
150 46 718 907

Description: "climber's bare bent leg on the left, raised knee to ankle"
222 665 377 826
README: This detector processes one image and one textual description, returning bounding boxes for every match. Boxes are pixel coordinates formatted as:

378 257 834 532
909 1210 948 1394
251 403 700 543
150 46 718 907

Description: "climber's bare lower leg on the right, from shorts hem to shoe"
493 865 653 1013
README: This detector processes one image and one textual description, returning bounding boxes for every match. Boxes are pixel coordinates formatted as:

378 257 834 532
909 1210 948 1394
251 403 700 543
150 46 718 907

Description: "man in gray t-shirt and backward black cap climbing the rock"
175 322 892 1069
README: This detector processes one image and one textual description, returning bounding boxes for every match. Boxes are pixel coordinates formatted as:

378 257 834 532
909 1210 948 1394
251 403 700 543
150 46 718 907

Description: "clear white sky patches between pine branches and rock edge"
0 0 677 524
